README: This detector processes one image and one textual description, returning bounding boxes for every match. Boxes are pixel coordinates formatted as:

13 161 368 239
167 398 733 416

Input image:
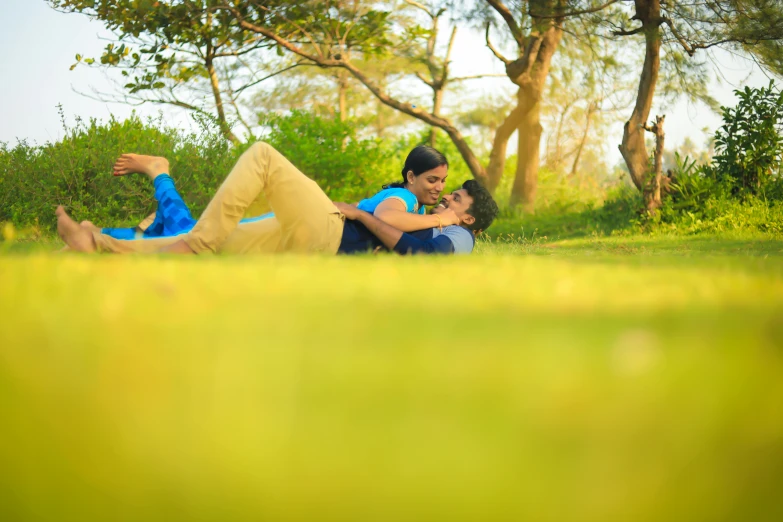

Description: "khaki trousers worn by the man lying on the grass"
93 142 344 254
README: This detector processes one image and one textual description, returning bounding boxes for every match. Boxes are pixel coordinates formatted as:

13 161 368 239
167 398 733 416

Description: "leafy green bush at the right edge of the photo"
608 83 783 234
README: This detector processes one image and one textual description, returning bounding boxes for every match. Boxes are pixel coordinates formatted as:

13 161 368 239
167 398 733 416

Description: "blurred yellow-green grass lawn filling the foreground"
0 235 783 521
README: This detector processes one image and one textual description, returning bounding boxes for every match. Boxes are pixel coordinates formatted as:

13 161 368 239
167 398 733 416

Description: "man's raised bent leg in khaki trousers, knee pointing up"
184 143 343 253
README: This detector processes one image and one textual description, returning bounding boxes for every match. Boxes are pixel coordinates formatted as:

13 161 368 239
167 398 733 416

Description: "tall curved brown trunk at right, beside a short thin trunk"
619 0 662 192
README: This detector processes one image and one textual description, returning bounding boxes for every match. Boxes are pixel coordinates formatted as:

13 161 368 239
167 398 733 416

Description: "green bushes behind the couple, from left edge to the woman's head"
0 108 398 231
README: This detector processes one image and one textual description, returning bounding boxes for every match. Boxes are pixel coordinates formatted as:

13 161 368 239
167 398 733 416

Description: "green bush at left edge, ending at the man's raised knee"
0 114 237 231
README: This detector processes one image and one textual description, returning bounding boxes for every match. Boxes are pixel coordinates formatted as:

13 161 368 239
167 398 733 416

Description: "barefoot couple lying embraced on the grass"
57 142 498 254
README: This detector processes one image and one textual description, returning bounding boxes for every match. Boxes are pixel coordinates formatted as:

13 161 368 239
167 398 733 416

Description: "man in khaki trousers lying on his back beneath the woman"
57 143 497 254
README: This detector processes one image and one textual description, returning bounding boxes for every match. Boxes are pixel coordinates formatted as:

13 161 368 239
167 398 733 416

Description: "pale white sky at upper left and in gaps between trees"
0 0 769 162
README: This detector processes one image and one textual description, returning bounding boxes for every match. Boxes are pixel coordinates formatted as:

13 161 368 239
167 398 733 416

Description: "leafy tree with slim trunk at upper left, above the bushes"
47 0 286 143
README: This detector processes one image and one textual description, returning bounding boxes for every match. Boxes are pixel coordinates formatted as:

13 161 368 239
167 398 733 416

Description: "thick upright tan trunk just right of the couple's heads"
506 24 563 213
